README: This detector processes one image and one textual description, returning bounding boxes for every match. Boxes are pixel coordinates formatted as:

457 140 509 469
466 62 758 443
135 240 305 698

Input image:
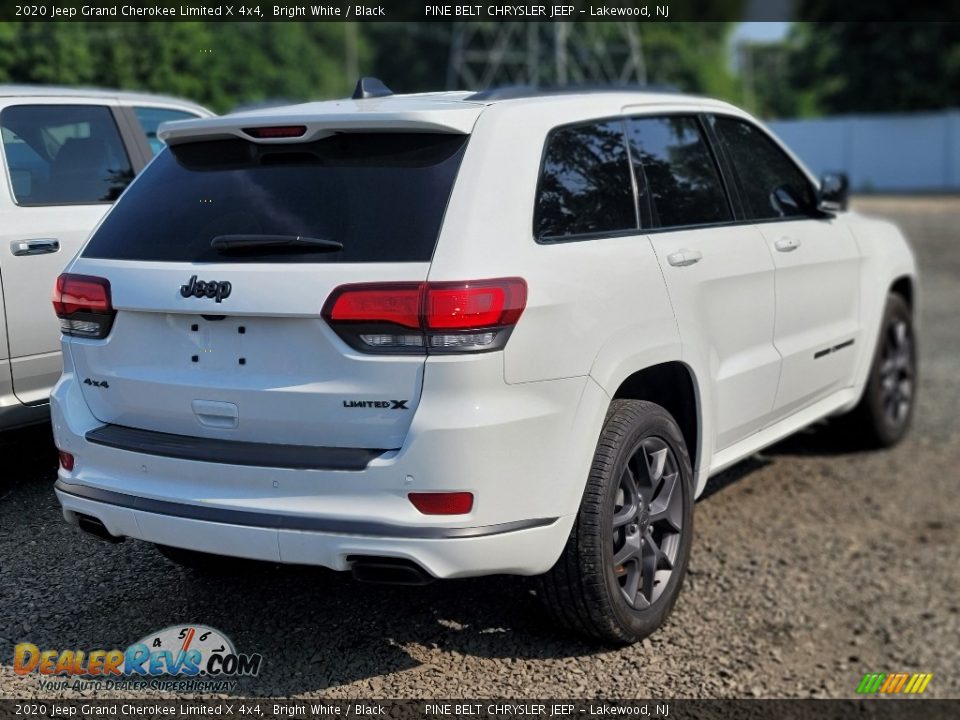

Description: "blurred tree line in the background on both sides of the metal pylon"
0 20 960 117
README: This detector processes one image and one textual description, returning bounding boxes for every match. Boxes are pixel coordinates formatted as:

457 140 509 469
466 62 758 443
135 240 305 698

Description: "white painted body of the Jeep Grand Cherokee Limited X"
52 91 916 578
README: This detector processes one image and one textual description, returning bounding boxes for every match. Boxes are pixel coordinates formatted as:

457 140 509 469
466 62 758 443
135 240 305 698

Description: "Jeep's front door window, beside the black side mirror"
714 117 816 220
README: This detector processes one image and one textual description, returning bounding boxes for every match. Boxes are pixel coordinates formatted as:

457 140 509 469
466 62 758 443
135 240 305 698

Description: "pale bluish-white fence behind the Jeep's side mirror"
768 110 960 192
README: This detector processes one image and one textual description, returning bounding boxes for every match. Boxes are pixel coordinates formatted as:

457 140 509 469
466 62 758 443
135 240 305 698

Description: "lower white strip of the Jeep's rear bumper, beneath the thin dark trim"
56 482 573 578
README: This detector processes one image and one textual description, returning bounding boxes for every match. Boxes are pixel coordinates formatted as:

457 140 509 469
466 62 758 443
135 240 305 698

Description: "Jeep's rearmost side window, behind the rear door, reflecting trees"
534 120 637 239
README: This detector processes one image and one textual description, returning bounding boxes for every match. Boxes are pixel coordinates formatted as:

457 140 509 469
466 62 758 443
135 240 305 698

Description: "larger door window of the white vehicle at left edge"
0 105 133 206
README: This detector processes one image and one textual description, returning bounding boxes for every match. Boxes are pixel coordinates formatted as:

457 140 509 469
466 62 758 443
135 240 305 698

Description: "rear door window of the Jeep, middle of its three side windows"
627 117 733 227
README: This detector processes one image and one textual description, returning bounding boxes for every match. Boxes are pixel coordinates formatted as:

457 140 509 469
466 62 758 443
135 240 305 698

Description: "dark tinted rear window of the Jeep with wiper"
83 133 467 263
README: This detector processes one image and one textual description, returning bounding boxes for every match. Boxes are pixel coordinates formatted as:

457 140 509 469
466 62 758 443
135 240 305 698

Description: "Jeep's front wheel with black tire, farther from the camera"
843 295 917 448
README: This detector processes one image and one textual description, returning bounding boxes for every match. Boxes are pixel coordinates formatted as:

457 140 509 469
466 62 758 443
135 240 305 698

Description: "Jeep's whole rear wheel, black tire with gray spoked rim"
538 400 693 645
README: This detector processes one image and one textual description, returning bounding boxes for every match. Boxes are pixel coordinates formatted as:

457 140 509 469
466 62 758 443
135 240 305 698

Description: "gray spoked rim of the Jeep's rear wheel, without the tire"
612 437 683 610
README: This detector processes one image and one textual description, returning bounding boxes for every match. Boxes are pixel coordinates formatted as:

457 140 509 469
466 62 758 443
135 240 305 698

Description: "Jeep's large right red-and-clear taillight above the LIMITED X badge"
322 278 527 354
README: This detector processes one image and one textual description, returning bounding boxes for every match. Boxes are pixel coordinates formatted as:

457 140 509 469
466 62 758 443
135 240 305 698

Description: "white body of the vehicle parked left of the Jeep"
0 85 211 430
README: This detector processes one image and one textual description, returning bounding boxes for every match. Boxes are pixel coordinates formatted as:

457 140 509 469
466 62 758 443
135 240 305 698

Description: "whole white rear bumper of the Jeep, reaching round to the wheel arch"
51 353 609 578
